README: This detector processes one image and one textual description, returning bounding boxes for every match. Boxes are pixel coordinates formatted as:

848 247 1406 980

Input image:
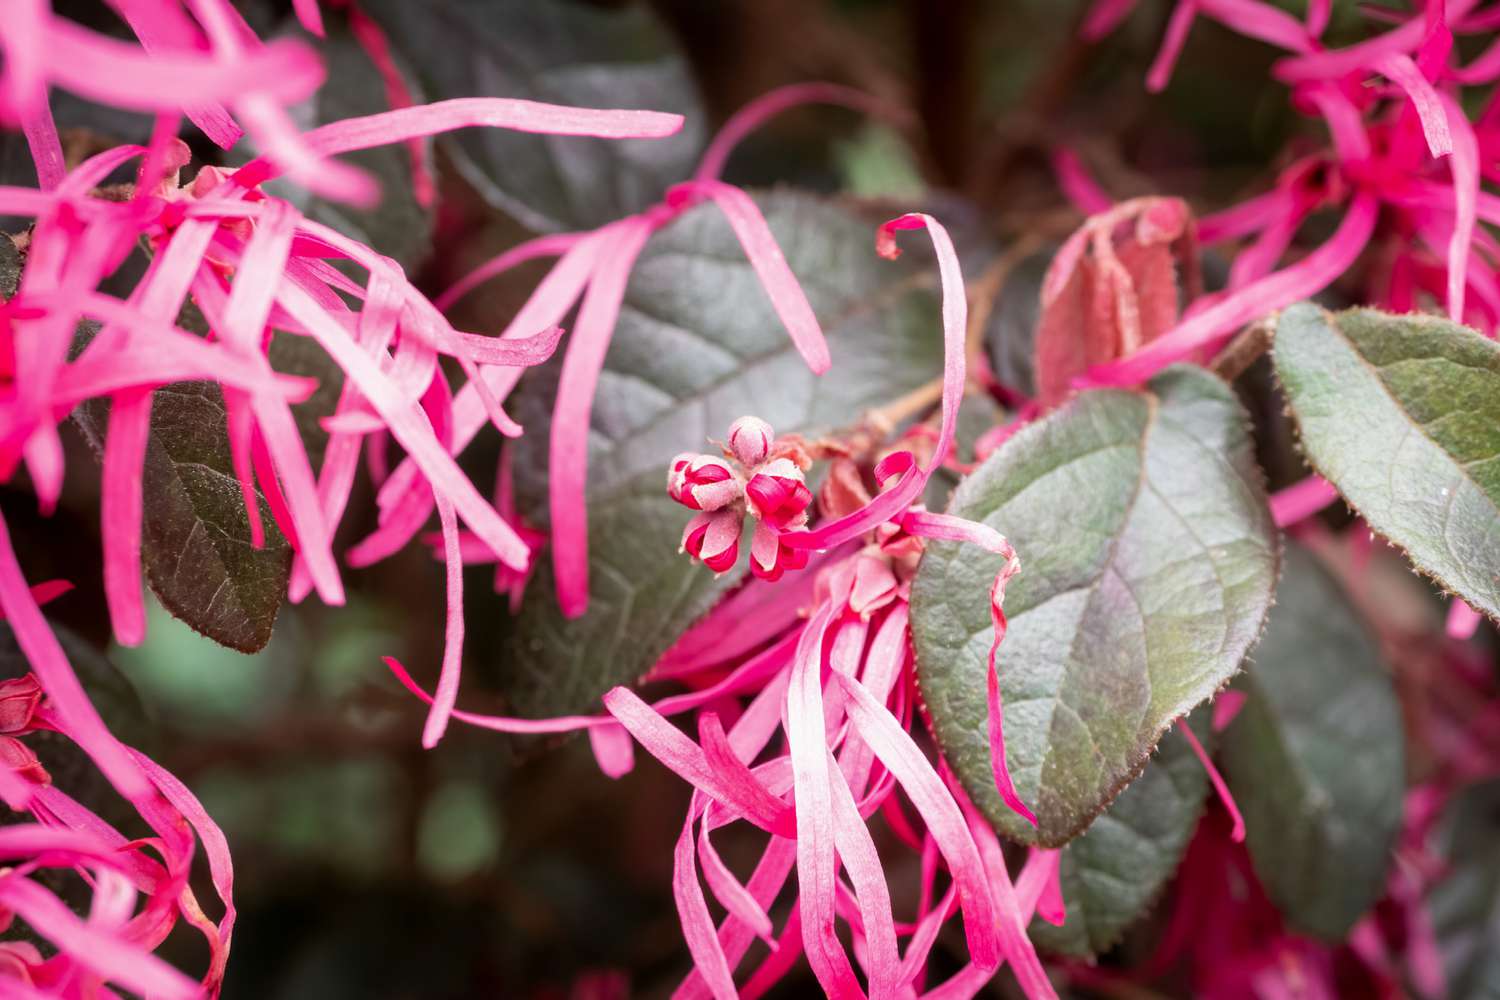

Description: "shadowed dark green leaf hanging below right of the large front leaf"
1221 546 1406 942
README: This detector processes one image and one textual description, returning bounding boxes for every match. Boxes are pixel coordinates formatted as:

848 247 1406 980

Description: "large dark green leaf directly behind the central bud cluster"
500 193 942 715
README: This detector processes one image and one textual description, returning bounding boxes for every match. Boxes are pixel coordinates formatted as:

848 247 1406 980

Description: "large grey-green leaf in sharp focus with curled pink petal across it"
912 366 1277 847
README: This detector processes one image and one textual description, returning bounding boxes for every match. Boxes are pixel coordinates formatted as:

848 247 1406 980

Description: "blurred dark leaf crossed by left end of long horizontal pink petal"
267 16 434 271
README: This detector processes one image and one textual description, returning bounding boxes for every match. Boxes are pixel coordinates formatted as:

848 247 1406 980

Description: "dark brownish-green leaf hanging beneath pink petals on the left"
74 382 291 652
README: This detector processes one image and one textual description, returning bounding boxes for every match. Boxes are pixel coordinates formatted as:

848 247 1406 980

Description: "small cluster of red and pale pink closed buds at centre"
666 417 813 580
